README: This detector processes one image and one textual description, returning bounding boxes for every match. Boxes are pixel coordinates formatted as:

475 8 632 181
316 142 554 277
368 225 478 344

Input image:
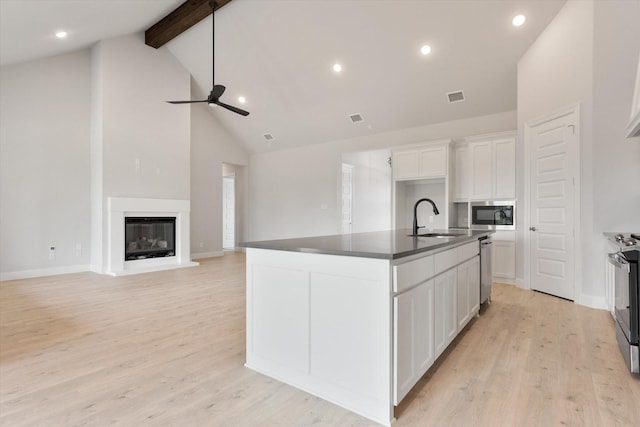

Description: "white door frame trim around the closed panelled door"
522 103 583 303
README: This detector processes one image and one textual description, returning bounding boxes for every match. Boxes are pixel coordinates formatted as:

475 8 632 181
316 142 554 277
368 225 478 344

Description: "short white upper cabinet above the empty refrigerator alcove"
392 141 450 180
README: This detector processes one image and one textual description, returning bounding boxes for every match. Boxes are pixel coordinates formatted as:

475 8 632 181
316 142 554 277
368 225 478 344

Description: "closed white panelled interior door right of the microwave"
526 110 578 300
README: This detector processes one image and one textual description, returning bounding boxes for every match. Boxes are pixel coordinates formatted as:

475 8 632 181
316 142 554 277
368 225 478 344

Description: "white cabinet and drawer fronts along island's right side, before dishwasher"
393 247 480 405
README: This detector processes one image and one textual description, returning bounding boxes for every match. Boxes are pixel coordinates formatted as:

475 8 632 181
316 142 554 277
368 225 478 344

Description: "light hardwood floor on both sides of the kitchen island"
0 254 640 427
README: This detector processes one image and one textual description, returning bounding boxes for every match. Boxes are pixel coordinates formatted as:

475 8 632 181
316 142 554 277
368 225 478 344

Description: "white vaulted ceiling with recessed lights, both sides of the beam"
0 0 564 152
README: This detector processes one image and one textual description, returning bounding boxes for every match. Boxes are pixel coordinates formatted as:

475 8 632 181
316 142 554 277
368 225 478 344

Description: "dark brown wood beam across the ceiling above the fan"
144 0 232 49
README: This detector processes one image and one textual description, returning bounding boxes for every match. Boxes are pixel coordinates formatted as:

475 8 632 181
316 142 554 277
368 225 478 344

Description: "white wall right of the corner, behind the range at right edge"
585 0 640 295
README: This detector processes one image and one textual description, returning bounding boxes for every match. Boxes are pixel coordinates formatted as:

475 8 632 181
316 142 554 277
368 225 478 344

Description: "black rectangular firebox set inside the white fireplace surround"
124 217 176 261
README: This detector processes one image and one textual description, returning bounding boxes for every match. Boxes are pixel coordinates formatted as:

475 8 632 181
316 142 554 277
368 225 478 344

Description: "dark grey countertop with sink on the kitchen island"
240 229 493 260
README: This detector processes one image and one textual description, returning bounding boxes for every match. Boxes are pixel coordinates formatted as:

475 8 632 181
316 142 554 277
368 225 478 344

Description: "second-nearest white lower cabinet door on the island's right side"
433 268 458 359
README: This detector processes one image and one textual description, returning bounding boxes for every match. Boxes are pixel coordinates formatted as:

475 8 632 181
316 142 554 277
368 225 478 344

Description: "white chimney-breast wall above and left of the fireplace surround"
91 34 191 271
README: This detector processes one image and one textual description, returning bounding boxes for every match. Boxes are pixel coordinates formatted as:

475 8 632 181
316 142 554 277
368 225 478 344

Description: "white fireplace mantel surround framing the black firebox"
105 197 199 276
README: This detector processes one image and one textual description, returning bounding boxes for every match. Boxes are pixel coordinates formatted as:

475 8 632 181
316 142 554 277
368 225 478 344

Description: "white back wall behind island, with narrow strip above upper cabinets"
248 111 516 240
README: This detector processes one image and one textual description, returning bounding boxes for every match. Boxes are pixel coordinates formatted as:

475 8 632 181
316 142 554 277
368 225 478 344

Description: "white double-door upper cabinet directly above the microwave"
454 132 516 200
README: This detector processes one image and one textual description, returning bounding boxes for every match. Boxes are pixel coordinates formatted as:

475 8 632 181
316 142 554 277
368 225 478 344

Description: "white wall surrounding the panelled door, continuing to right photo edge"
516 0 640 301
